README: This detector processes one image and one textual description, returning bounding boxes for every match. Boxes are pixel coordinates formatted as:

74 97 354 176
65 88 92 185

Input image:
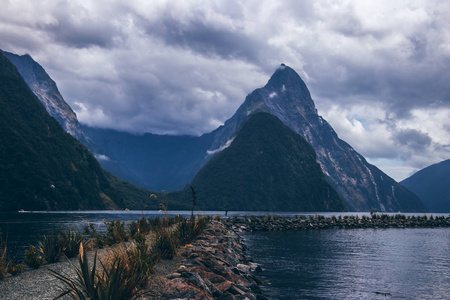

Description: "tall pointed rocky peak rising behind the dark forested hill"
211 64 425 211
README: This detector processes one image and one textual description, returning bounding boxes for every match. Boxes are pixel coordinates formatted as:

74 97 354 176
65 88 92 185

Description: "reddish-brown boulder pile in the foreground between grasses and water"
161 220 266 300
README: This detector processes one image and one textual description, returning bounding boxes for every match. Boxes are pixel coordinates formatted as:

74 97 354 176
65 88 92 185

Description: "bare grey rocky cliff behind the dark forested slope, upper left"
3 52 90 149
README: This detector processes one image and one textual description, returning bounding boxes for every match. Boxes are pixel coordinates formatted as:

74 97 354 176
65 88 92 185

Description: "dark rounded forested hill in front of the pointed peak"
185 113 345 211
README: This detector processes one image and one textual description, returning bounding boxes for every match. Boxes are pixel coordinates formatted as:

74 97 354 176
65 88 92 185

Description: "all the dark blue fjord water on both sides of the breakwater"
0 211 450 299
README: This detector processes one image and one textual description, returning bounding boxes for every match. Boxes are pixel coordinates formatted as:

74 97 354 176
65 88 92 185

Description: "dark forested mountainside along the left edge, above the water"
0 51 163 211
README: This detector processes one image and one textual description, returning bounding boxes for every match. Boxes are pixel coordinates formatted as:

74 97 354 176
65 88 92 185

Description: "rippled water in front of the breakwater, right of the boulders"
243 228 450 299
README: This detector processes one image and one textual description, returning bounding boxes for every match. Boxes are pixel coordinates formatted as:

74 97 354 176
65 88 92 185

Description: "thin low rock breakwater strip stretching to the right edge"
225 214 450 231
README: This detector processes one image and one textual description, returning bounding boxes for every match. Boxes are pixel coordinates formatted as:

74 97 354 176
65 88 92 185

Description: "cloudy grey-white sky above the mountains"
0 0 450 180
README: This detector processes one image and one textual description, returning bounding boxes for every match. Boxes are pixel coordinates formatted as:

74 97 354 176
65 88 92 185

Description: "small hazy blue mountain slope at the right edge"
400 160 450 213
